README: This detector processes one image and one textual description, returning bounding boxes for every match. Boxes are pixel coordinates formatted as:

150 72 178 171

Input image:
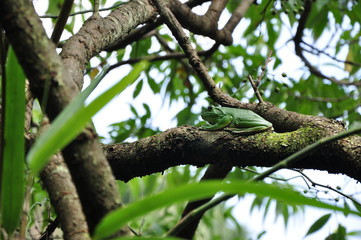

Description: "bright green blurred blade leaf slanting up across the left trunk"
27 62 148 174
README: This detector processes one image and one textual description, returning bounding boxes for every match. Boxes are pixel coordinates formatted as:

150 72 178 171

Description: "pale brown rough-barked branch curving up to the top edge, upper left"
60 0 156 90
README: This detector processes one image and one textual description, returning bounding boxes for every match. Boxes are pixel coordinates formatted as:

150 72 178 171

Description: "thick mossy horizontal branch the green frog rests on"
103 114 361 181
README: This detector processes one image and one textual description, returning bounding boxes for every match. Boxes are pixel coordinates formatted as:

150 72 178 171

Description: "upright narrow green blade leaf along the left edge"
0 48 25 234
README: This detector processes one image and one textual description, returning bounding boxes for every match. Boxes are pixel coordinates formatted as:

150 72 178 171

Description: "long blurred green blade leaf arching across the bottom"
93 181 361 240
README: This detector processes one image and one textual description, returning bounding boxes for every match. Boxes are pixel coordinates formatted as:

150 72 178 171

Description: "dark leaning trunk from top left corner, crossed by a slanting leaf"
0 0 120 231
